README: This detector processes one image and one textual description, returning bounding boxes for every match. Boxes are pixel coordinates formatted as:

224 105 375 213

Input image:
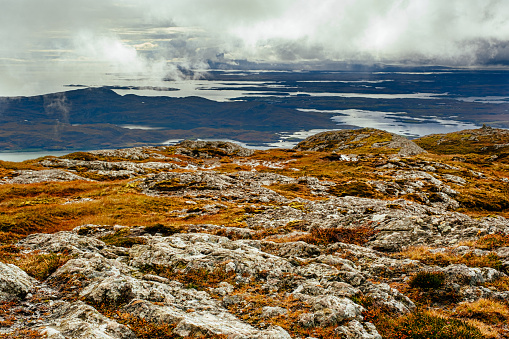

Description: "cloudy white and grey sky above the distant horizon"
0 0 509 96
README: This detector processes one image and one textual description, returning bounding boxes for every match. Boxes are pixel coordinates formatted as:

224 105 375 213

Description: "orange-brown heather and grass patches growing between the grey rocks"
0 129 509 339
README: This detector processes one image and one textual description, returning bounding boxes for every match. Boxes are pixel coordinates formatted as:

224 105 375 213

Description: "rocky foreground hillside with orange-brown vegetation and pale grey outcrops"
0 129 509 339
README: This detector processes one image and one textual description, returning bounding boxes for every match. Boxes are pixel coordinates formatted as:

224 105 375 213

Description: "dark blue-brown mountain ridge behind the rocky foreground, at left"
0 87 338 150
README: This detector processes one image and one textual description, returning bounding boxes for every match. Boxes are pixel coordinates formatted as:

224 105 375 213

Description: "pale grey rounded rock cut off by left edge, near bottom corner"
0 262 36 301
